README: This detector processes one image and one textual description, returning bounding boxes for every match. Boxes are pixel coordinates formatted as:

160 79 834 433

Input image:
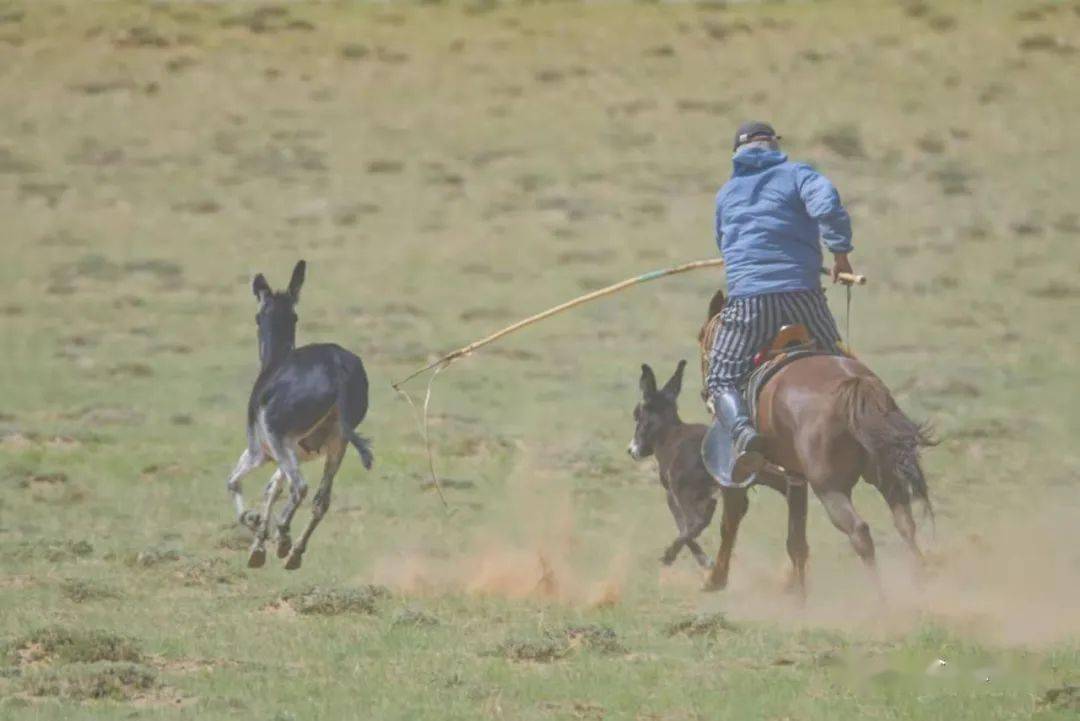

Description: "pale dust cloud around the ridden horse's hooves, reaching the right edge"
682 490 1080 647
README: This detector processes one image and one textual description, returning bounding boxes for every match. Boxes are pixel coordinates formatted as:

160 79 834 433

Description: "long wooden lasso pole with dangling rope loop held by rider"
391 258 866 507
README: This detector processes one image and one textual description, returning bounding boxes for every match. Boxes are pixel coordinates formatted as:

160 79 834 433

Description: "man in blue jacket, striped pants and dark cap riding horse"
706 122 852 486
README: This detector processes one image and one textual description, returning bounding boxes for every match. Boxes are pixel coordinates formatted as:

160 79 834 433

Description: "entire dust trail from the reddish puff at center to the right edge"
374 470 1080 645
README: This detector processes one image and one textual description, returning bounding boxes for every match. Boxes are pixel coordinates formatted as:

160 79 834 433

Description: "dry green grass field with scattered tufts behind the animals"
0 0 1080 721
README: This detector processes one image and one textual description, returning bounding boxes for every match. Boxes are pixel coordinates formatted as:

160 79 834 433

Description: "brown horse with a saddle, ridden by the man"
705 289 934 595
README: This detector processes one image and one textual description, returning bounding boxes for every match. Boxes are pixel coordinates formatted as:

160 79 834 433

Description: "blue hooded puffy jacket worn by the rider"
716 147 852 298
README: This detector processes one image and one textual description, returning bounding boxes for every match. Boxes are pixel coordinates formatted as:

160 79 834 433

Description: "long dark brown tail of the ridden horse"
840 376 936 521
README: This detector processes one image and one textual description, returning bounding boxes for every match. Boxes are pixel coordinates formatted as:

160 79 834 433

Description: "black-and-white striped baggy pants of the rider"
706 288 840 398
